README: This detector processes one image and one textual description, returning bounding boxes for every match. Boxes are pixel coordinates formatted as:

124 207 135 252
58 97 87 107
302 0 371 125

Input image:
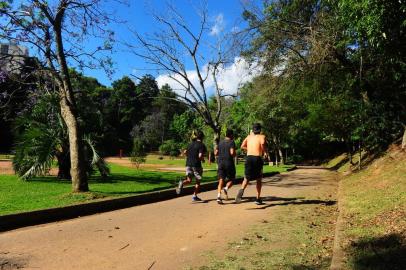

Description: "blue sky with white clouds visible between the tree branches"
0 0 263 94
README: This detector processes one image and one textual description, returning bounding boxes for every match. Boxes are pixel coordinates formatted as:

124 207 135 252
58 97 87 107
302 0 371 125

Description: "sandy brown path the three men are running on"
0 168 337 270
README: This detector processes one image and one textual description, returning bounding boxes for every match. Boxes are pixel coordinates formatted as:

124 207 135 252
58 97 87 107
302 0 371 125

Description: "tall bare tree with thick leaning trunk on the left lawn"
0 0 119 192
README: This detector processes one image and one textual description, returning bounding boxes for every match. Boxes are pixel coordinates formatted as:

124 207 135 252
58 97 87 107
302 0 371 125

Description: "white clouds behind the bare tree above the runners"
156 57 261 95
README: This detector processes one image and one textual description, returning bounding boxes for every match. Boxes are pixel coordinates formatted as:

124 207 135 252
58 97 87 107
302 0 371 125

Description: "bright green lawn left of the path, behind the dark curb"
0 163 289 215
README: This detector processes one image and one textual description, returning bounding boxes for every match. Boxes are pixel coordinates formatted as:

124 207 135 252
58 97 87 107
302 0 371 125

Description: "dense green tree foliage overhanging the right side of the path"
235 0 406 162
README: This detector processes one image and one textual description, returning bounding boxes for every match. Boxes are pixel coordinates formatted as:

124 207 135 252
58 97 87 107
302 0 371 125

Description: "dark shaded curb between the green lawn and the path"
0 167 296 232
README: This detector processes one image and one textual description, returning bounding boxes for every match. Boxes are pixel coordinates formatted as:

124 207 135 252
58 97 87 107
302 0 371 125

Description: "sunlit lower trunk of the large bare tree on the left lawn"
60 98 89 192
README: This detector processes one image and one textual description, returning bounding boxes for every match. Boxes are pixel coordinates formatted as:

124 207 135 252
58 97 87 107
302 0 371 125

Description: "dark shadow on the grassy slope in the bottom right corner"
347 233 406 270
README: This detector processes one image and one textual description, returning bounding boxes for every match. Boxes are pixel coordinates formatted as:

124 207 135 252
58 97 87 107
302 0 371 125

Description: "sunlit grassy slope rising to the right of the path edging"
336 145 406 269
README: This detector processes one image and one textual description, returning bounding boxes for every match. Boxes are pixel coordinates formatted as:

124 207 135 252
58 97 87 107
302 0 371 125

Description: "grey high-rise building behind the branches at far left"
0 43 29 73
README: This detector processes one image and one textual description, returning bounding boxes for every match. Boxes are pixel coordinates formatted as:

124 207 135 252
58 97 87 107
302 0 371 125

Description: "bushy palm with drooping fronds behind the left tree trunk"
13 93 109 179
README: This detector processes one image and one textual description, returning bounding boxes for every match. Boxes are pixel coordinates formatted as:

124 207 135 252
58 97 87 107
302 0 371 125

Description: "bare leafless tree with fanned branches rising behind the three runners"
127 4 235 142
